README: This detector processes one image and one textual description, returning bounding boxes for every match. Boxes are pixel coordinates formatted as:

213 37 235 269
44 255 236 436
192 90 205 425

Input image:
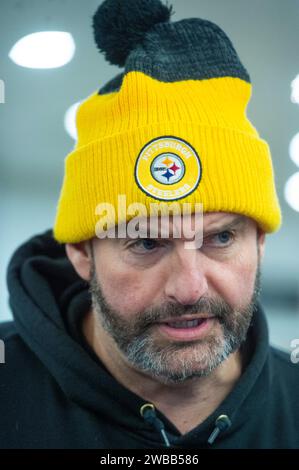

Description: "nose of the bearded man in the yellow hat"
165 247 208 305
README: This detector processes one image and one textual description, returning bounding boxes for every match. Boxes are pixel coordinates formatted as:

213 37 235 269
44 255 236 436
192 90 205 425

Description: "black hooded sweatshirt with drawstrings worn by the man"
0 230 299 449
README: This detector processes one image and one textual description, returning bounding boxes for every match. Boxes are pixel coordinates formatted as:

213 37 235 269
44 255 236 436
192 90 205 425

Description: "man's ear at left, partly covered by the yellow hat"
65 240 92 281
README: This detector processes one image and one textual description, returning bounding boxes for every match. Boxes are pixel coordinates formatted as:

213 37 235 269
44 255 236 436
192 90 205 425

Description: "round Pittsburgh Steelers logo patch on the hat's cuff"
135 136 202 201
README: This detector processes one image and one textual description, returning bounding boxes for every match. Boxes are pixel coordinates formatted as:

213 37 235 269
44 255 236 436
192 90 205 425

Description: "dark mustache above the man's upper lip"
140 297 233 323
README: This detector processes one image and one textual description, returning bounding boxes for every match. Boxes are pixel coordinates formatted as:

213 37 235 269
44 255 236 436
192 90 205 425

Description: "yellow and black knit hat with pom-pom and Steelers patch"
54 0 281 243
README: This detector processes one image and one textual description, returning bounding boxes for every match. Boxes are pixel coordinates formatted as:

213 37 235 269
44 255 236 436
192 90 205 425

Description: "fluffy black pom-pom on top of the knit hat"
92 0 173 67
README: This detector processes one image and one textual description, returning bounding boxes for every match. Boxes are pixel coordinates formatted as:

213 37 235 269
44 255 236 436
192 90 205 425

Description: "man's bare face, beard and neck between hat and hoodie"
66 209 264 434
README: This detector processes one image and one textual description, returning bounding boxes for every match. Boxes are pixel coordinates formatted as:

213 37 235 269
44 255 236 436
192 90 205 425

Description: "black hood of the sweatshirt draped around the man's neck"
7 230 272 448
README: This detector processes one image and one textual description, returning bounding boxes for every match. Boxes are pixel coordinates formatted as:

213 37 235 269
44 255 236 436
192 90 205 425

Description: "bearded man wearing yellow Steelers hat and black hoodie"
0 0 299 449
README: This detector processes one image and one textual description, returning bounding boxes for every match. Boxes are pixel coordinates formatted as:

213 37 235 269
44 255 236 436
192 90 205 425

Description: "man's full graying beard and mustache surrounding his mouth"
90 253 261 385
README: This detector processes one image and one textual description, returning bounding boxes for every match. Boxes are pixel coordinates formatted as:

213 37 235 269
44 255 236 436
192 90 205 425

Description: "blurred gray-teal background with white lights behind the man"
0 0 299 350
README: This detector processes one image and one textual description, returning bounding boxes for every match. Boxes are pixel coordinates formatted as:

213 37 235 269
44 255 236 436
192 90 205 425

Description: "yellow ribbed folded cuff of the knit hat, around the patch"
54 122 281 243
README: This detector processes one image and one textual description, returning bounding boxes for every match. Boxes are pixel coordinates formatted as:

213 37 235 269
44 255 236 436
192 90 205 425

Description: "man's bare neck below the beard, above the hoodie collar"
82 310 244 434
